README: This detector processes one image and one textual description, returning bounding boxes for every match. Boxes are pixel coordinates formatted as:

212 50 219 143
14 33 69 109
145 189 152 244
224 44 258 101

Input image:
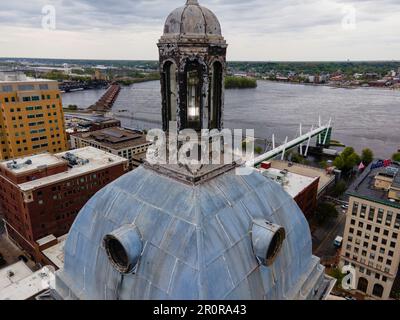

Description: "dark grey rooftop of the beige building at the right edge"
347 160 400 208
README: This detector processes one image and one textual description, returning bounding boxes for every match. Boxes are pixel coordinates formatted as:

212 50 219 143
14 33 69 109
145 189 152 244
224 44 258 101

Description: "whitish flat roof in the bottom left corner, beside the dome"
0 267 55 300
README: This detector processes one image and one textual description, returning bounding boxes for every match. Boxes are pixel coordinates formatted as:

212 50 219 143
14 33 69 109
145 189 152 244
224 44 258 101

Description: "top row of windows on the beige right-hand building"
352 202 400 229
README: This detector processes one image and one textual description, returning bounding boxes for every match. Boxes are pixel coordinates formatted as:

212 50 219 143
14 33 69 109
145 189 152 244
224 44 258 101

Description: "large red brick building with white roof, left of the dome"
0 147 128 261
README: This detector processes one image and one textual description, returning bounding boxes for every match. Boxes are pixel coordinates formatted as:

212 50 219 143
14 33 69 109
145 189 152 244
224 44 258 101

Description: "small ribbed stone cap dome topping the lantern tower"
164 0 222 37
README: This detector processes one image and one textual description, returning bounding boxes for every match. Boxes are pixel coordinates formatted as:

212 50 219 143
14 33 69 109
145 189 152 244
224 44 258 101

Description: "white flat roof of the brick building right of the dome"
257 168 318 198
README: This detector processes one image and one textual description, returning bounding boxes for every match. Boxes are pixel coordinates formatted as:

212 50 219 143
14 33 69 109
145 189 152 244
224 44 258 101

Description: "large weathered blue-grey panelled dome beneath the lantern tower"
56 167 330 300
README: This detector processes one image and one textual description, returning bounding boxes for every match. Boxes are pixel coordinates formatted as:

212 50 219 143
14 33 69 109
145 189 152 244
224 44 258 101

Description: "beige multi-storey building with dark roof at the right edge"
341 161 400 299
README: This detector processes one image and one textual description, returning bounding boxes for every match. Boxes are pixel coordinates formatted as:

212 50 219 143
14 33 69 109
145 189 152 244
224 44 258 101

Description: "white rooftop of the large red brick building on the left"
0 147 127 191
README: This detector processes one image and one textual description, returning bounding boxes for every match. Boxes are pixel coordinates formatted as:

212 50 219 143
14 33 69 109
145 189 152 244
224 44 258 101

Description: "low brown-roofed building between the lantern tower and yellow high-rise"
71 127 151 169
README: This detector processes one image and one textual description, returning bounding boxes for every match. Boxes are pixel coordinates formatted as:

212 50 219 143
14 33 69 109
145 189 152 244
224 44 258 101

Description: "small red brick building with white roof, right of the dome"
258 162 320 219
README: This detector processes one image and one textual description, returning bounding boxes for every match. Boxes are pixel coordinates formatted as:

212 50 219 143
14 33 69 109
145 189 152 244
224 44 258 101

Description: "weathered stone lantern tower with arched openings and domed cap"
158 0 227 130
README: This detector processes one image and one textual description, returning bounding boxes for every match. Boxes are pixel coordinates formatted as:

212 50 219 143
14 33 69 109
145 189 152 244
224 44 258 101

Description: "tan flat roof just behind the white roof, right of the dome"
269 160 335 193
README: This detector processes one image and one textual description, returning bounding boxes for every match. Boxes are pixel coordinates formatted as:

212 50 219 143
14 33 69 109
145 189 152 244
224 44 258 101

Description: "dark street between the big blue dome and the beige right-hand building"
313 206 346 260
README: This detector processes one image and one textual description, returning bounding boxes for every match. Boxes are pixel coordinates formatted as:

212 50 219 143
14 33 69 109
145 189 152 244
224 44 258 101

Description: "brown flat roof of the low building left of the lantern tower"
73 127 149 150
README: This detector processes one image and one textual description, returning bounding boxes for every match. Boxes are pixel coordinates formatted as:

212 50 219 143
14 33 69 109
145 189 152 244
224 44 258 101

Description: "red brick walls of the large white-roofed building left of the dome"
0 164 125 255
